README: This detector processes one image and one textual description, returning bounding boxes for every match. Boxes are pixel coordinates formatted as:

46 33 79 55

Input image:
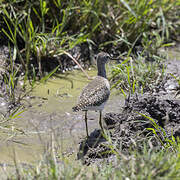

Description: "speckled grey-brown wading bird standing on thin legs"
72 52 115 137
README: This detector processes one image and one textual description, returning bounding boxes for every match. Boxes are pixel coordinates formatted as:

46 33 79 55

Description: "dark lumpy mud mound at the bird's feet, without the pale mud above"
78 93 180 164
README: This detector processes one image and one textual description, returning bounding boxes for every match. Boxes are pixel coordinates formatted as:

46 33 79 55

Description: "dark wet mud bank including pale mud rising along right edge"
77 47 180 165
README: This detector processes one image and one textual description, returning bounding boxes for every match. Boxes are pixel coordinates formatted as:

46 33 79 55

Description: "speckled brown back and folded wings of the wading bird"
73 76 110 111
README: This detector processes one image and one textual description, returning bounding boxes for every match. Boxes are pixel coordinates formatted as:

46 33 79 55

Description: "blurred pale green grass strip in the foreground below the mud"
5 141 180 180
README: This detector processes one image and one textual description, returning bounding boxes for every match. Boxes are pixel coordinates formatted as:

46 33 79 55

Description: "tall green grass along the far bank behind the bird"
0 0 180 79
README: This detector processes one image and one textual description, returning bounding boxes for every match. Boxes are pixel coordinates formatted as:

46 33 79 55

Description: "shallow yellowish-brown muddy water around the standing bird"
0 65 124 164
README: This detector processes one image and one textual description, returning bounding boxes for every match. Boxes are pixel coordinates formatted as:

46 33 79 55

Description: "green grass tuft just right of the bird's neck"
110 56 165 94
